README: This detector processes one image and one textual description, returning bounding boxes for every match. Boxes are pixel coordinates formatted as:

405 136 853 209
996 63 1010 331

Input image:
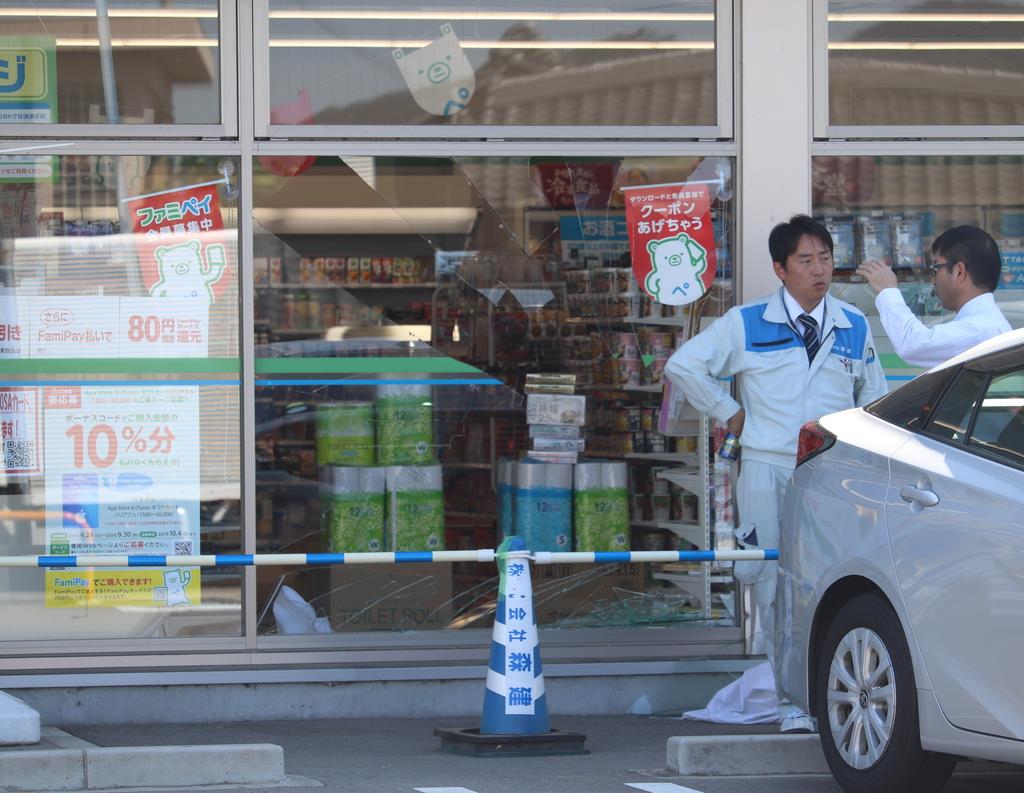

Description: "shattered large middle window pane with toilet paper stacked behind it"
254 156 734 634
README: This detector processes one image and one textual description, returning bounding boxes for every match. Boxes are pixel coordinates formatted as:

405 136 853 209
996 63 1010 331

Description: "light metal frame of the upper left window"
2 0 237 139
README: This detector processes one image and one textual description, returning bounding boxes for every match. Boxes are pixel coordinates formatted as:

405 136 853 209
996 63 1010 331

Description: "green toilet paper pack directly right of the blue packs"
572 462 630 551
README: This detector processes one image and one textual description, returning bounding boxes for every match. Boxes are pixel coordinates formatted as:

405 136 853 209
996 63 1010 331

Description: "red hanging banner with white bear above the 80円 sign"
125 180 234 303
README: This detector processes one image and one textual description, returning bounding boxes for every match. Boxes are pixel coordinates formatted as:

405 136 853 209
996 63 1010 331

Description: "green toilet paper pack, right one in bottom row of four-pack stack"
387 465 444 551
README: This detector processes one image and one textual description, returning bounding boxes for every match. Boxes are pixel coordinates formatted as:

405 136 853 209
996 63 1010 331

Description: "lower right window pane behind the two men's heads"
811 156 1024 382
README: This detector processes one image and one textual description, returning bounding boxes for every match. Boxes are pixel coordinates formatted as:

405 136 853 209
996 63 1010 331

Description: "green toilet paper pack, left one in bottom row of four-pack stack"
319 465 385 553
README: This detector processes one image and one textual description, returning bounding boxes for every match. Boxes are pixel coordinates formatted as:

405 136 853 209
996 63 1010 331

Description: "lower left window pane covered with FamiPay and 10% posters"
0 156 242 639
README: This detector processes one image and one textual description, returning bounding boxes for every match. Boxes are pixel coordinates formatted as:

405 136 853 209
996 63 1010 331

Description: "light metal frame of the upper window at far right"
811 0 1024 140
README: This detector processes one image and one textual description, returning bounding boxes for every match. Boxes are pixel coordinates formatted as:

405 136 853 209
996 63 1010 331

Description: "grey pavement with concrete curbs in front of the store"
0 716 1024 793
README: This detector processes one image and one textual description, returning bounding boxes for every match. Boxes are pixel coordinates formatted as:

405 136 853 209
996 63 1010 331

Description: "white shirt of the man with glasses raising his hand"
874 288 1012 369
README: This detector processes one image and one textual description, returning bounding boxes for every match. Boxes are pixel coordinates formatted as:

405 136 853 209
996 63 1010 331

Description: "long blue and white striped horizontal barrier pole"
0 548 778 568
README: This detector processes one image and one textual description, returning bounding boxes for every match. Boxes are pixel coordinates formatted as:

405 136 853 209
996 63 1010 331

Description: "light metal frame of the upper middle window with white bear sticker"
252 0 737 141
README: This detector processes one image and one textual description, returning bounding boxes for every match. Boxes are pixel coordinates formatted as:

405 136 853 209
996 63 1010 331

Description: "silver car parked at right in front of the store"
773 330 1024 793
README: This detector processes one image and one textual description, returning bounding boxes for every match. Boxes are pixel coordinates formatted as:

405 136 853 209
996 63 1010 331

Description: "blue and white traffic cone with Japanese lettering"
480 537 551 736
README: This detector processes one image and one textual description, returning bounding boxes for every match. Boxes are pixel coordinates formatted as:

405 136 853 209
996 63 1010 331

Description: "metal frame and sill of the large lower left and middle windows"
0 139 744 676
